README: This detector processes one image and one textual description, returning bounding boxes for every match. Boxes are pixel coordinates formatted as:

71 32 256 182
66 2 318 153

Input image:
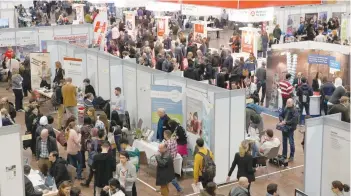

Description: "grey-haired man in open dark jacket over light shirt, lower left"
35 129 58 168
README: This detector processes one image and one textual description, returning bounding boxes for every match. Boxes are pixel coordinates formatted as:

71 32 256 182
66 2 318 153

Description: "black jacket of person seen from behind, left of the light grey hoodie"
92 153 116 188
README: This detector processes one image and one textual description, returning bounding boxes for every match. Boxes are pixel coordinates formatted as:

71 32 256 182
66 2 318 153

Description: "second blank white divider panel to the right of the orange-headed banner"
97 56 111 100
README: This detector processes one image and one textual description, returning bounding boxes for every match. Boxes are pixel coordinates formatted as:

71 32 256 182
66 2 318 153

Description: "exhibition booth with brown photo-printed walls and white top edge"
266 41 350 113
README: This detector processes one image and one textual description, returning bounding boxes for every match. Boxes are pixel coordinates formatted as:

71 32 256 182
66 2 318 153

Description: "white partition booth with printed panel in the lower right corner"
304 114 350 196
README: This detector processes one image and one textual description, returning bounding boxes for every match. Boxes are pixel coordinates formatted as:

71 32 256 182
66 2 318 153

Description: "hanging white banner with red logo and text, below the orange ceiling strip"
228 7 274 22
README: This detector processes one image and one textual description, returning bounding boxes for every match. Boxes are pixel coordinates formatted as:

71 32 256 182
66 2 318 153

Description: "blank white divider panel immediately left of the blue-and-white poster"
136 70 156 131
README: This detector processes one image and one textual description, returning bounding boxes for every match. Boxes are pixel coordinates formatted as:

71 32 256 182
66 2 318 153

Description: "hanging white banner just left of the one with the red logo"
182 4 223 16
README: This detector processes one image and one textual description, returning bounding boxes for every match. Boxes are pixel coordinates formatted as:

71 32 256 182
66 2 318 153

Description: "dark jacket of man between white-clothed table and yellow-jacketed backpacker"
156 153 175 186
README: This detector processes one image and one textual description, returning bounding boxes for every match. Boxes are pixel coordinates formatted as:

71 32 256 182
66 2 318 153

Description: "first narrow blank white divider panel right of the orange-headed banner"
87 50 98 89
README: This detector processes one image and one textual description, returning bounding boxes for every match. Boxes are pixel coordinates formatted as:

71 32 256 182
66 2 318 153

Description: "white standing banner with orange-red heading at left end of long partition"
63 57 84 85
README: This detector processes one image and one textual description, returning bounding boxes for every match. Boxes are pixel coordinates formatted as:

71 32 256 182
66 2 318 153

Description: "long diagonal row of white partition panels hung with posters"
47 41 246 183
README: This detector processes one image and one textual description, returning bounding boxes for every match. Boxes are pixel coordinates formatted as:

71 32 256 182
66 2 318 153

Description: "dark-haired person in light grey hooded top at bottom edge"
115 151 137 196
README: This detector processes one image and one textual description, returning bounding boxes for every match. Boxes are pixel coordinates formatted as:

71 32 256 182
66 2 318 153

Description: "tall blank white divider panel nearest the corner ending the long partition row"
211 92 231 184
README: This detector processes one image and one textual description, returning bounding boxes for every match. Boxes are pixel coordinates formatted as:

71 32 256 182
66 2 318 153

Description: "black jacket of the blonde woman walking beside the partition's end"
228 152 256 182
